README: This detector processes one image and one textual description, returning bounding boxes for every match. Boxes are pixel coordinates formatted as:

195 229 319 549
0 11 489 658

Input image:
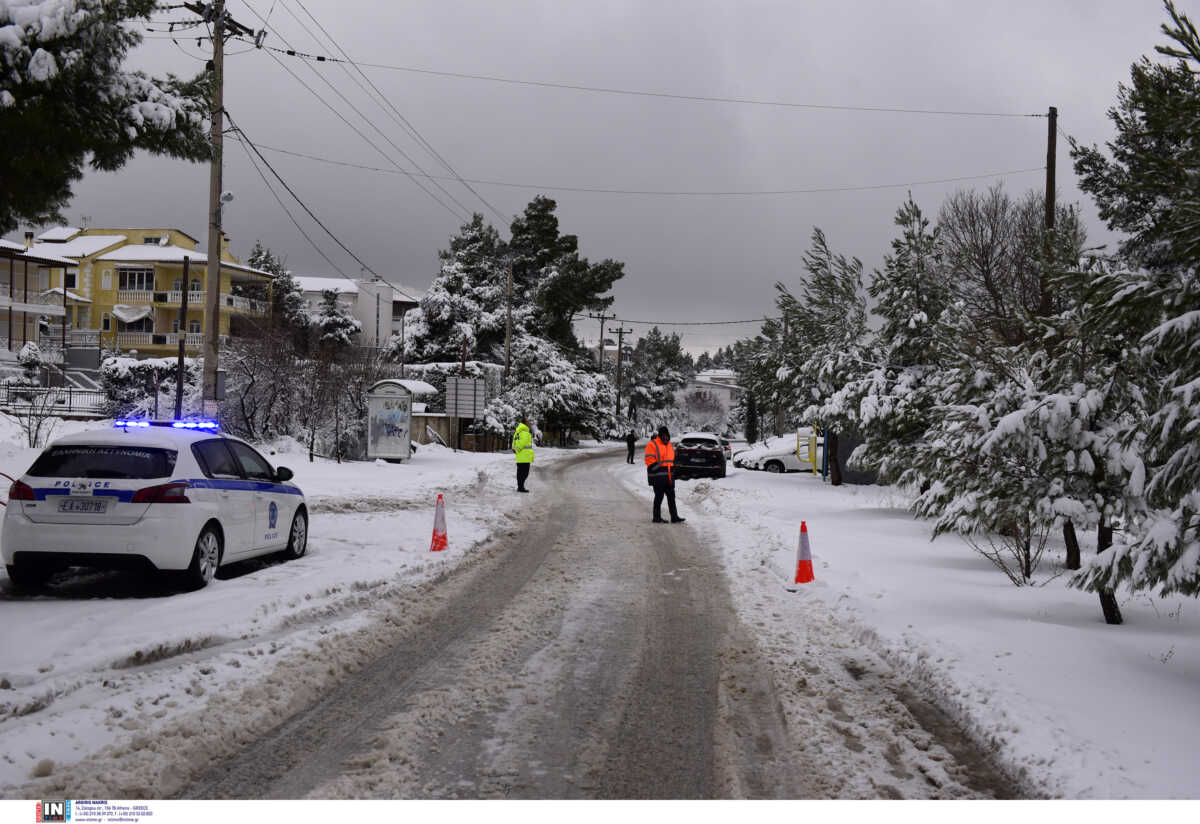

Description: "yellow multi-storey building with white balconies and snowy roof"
18 227 272 357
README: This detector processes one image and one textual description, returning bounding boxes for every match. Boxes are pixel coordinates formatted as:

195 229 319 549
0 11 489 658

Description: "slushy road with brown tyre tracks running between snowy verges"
169 453 1013 799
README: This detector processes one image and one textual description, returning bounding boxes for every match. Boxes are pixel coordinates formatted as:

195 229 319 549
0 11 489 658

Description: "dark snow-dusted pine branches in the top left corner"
0 0 209 234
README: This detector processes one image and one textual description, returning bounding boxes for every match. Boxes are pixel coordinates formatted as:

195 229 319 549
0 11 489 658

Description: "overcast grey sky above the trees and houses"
51 0 1176 351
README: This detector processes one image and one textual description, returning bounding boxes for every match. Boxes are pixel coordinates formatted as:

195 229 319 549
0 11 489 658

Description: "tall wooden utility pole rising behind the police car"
184 0 254 416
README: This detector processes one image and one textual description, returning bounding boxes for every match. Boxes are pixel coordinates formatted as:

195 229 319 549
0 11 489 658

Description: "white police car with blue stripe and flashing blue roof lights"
0 421 308 589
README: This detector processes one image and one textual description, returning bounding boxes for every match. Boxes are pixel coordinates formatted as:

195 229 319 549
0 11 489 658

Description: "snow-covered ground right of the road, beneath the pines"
610 464 1200 799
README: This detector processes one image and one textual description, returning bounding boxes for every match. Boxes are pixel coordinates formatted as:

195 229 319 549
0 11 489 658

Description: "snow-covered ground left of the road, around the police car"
0 415 585 798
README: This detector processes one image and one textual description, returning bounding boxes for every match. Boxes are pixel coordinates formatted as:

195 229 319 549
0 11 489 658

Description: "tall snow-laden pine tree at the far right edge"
1072 0 1200 596
